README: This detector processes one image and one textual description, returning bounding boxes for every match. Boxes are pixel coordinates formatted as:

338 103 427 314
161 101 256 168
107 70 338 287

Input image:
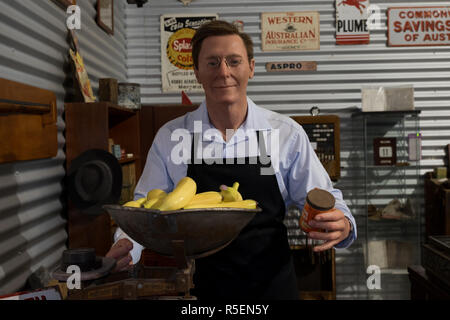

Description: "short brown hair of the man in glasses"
192 20 253 69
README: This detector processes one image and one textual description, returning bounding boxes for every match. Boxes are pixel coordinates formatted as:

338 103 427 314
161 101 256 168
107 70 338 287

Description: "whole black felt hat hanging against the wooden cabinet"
67 149 122 215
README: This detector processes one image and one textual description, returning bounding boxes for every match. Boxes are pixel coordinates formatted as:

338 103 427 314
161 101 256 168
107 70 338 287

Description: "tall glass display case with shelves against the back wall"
351 111 423 299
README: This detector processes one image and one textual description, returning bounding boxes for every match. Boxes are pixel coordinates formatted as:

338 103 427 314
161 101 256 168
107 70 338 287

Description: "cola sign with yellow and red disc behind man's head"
161 14 218 92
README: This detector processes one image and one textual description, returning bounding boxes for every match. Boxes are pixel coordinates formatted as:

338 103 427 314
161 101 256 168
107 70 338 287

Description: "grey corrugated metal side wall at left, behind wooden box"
0 0 127 294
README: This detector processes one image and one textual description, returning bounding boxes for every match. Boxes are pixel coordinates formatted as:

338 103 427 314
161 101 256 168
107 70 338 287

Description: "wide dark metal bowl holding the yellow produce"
103 205 262 259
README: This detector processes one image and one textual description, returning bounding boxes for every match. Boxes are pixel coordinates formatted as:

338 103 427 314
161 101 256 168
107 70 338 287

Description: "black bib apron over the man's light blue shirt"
187 133 299 300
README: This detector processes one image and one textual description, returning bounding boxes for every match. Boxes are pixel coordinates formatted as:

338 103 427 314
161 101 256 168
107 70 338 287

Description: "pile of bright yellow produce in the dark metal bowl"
124 177 257 211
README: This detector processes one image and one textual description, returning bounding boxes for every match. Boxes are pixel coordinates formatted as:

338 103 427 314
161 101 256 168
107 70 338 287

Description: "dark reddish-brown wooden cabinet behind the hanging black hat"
65 102 198 256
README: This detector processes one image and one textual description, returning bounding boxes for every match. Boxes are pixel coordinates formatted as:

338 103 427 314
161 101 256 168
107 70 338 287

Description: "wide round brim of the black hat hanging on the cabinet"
67 149 122 215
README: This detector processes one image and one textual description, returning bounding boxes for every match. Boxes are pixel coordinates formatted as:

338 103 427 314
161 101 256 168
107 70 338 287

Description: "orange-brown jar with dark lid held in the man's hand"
299 188 336 233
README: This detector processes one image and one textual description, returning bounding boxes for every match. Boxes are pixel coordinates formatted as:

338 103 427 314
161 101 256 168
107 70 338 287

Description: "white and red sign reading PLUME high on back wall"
336 0 370 45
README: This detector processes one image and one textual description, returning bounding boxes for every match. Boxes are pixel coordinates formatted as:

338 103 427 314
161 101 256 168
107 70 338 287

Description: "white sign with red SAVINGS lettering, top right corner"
387 7 450 47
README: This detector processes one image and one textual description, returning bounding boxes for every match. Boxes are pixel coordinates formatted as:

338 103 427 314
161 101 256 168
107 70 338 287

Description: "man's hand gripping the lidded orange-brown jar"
308 209 350 252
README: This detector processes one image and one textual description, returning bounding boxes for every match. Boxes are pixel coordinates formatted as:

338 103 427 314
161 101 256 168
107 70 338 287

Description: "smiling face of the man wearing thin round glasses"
194 35 255 104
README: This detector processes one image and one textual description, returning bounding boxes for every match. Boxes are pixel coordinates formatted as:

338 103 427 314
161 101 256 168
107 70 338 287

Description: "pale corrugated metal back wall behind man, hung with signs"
126 0 450 299
